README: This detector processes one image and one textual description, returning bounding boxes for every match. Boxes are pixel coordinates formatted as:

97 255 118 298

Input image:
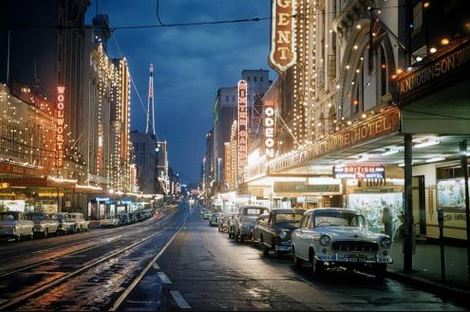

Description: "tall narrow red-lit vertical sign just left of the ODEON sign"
237 80 248 176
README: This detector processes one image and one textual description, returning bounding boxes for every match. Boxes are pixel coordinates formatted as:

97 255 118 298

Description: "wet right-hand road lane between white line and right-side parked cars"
124 209 465 311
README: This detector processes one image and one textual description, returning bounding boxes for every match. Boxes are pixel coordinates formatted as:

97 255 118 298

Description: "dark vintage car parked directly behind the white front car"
254 209 305 257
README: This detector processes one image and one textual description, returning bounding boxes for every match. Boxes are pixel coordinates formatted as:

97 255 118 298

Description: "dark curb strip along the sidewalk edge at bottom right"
387 269 470 307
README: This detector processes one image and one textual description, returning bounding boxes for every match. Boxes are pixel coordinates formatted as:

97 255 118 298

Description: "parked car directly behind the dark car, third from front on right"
231 206 269 242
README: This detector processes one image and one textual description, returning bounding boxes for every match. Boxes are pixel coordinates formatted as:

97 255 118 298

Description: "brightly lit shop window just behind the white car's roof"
348 193 403 240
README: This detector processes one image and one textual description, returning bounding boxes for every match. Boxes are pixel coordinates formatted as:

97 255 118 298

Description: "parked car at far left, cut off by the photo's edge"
0 211 34 241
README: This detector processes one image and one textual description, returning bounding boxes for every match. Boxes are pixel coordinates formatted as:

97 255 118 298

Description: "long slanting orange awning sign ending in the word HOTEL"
269 107 400 173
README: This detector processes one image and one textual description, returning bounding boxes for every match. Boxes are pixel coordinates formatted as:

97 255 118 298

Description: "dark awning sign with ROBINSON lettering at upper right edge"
398 42 470 104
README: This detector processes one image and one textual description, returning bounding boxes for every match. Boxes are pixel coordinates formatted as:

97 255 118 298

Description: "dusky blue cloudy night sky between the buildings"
86 0 274 183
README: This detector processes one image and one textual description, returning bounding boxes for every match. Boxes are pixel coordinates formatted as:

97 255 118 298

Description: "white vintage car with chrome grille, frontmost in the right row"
292 208 392 278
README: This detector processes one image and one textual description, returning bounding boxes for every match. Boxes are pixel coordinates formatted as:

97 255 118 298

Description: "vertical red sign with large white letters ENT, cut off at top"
269 0 295 75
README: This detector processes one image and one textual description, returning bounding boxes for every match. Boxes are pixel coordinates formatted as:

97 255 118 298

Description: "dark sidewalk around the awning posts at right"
388 241 470 302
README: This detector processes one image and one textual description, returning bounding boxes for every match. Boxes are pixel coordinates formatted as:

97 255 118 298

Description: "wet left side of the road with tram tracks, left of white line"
0 204 188 311
